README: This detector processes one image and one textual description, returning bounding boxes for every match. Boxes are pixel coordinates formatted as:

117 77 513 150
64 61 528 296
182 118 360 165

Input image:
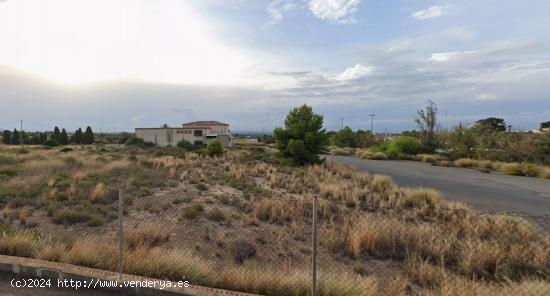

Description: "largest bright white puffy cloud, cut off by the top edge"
309 0 361 23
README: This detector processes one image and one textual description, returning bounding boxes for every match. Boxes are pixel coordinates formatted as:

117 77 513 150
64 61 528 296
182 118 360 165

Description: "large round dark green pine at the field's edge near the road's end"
274 105 328 165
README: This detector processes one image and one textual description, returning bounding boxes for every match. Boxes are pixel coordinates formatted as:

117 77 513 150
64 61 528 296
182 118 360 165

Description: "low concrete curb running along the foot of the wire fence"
0 255 259 296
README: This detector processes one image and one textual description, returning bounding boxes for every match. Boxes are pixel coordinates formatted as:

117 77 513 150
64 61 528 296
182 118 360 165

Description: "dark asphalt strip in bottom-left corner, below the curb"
0 272 130 296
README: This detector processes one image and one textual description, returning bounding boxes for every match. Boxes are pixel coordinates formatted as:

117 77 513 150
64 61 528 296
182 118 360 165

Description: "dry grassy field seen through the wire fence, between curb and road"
0 145 550 296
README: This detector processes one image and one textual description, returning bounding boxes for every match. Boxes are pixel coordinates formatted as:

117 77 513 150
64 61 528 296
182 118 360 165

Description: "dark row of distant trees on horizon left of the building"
2 126 95 146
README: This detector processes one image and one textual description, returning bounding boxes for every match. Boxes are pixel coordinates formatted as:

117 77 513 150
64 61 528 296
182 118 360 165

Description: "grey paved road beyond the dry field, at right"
335 156 550 216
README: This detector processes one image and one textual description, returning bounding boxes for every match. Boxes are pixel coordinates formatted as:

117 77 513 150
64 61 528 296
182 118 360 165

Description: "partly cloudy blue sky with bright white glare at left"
0 0 550 132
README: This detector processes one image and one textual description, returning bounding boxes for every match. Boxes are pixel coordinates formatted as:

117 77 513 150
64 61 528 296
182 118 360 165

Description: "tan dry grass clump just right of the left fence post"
124 223 170 249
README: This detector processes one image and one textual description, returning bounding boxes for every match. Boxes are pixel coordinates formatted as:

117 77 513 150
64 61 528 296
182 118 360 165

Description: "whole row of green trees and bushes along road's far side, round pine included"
274 101 550 165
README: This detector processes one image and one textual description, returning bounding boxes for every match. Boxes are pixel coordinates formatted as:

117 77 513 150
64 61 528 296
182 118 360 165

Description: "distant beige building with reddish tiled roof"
136 121 232 147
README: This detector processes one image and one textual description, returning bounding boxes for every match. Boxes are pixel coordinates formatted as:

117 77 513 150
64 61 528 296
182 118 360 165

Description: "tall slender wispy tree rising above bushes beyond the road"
414 100 438 153
